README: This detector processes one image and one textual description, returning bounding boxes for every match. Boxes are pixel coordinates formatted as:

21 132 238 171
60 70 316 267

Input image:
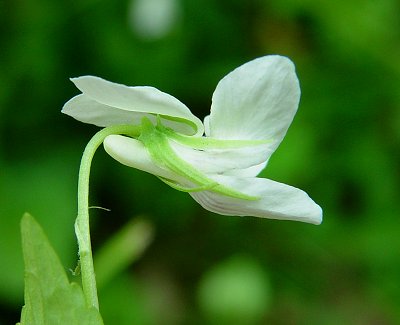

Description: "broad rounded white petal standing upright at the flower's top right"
206 55 300 160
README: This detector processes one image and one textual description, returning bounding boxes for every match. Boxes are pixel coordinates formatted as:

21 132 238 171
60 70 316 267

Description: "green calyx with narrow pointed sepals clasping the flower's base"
138 117 260 200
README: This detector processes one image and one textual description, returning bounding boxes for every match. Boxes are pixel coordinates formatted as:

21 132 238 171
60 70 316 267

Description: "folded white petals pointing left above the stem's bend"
62 76 204 136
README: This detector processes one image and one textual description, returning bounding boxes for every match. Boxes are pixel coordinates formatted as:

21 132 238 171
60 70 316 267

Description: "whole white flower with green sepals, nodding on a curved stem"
63 55 322 224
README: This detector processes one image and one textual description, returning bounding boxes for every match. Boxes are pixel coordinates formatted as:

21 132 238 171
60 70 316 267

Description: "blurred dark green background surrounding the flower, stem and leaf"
0 0 400 325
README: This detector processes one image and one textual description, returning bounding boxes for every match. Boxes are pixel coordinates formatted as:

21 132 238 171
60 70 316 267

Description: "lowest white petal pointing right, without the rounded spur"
189 175 322 224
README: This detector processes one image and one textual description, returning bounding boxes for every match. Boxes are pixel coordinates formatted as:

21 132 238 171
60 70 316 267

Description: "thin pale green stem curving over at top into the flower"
75 125 141 309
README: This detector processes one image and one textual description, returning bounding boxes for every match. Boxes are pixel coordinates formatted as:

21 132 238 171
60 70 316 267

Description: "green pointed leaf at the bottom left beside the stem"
20 214 103 325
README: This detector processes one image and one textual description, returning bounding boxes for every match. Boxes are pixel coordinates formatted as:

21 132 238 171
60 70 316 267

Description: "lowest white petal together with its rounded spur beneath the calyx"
104 135 322 224
